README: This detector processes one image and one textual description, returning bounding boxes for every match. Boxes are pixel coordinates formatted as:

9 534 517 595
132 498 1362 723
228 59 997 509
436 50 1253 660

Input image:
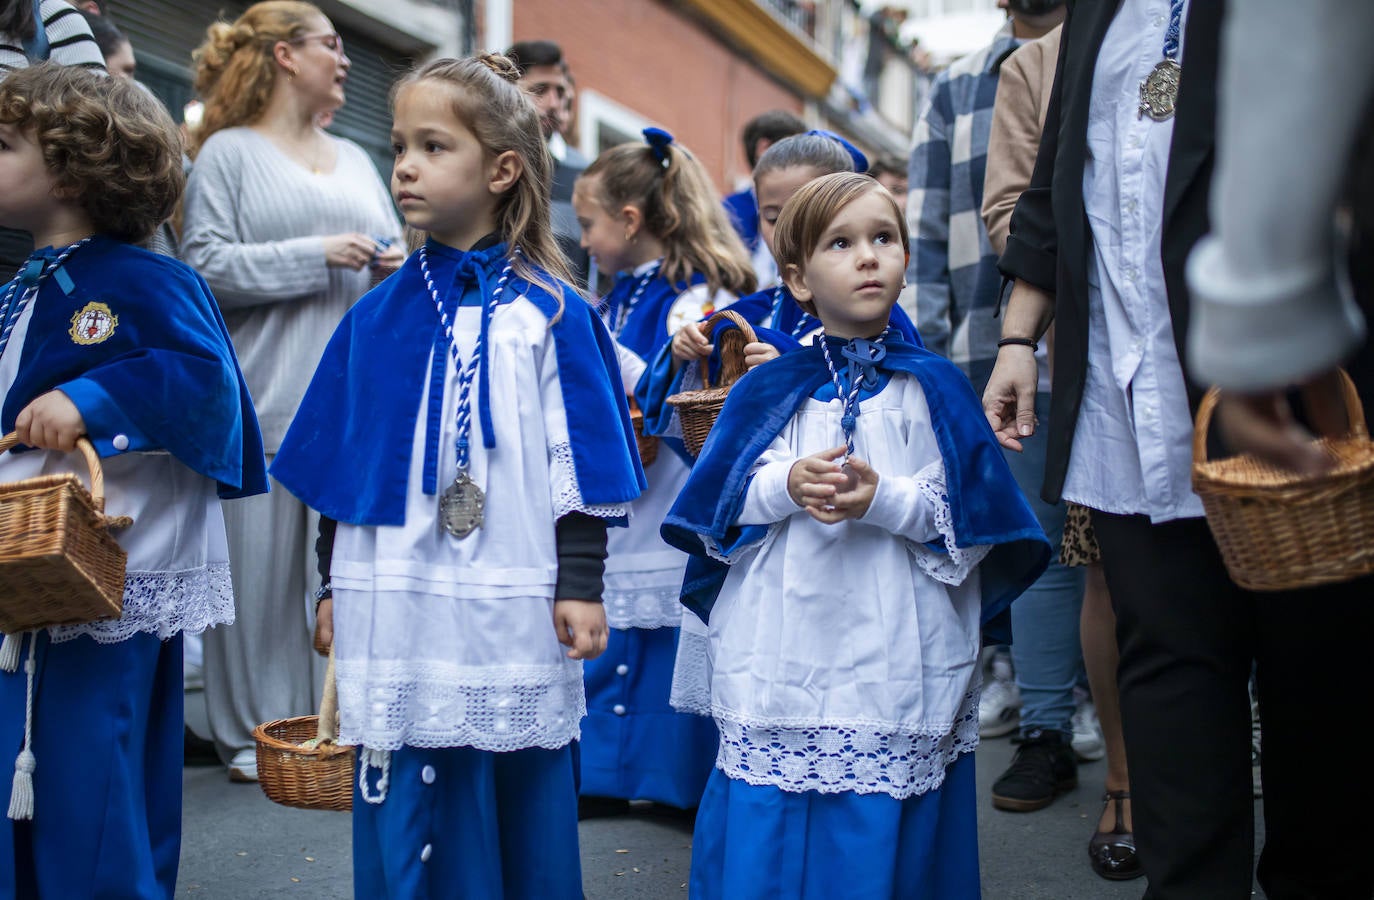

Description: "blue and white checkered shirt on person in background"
907 21 1021 392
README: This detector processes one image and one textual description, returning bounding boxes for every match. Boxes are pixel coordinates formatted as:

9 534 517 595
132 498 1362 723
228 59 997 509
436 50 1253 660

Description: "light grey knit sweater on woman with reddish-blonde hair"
181 128 401 453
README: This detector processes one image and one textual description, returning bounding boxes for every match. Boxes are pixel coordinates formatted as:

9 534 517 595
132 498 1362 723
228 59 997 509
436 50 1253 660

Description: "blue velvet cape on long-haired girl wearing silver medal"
272 240 644 525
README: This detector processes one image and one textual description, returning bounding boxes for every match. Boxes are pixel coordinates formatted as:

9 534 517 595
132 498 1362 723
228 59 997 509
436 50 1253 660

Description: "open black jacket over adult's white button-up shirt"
998 0 1221 503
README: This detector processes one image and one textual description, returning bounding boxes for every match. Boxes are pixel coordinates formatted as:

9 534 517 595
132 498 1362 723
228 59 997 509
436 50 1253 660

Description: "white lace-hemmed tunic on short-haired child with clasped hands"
702 374 988 800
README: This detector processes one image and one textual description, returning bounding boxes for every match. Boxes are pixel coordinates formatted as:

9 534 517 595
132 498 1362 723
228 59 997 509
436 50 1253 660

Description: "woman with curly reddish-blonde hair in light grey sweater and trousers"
183 1 403 780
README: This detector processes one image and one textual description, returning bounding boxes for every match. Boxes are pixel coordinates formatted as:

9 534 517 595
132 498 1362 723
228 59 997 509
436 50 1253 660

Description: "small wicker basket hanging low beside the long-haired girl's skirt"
253 647 354 812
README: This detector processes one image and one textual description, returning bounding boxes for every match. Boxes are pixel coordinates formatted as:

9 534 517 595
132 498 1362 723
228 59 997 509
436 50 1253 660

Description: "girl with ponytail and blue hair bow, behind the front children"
573 128 754 813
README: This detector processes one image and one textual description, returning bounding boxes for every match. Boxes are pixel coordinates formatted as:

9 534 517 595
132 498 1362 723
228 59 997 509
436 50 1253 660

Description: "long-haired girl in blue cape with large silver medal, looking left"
272 55 643 900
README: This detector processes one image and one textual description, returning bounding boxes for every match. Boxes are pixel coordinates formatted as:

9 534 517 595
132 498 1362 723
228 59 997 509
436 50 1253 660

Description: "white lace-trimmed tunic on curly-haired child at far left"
0 288 234 643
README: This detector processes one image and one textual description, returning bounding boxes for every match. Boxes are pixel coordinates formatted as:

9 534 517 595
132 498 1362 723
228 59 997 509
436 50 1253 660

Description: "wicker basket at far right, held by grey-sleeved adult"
1193 372 1374 591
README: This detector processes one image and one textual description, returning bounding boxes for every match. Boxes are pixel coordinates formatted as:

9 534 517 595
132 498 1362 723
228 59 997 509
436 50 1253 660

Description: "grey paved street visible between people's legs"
177 720 1264 900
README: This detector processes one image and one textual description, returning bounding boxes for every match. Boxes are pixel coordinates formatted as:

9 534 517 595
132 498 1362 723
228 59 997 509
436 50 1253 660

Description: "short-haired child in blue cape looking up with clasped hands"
664 173 1050 900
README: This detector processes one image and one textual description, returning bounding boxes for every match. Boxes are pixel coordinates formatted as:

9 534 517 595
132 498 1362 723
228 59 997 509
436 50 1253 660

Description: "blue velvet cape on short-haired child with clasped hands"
662 338 1050 642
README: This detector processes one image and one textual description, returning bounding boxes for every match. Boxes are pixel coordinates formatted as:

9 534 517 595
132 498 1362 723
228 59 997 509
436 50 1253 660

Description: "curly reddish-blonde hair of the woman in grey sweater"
190 0 324 157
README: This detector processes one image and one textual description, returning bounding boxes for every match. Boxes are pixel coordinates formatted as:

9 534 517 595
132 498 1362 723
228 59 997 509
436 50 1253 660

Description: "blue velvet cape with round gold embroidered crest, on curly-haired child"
0 235 268 497
